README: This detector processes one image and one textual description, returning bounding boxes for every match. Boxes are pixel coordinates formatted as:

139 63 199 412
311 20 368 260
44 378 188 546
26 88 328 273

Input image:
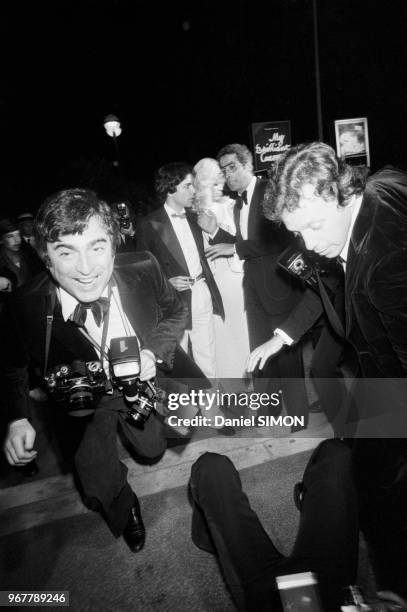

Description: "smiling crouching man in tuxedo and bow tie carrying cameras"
0 189 202 552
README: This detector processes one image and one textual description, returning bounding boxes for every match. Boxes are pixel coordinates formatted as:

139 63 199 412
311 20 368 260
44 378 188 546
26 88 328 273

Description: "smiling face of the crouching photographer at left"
47 216 114 302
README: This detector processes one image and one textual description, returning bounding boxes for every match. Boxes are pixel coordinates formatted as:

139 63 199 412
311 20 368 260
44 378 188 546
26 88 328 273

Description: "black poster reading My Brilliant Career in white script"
252 121 291 172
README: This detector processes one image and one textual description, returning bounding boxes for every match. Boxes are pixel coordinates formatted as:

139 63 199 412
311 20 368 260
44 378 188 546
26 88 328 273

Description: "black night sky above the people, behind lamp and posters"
0 0 407 214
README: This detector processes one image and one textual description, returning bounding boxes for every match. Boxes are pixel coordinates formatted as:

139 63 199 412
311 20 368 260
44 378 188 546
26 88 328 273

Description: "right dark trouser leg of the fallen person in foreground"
288 440 358 610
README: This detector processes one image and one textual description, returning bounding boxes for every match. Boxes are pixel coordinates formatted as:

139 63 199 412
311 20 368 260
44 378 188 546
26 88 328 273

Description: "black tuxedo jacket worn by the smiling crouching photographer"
0 253 190 420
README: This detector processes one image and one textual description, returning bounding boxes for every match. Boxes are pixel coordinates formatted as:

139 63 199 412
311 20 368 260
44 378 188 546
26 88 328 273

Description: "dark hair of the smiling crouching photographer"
34 189 120 262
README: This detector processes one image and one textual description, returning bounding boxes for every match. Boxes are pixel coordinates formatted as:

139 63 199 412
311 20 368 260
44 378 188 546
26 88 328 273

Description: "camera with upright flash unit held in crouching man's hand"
110 336 162 429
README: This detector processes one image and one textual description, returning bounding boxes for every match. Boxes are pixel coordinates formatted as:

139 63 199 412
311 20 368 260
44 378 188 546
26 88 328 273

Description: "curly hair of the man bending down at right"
263 142 368 221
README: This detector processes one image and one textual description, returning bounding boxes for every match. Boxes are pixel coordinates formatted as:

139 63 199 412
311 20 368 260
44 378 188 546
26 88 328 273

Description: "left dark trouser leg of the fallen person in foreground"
191 453 284 610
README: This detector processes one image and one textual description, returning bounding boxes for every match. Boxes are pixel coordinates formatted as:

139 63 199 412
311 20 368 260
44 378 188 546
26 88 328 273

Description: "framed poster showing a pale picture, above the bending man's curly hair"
335 117 370 166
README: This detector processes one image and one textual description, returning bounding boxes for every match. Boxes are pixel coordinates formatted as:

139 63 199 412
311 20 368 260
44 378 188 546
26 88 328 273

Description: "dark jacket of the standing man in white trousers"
136 207 225 329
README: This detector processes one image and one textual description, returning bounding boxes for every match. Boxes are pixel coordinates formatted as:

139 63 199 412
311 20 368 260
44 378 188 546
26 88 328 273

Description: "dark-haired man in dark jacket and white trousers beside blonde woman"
136 162 225 378
